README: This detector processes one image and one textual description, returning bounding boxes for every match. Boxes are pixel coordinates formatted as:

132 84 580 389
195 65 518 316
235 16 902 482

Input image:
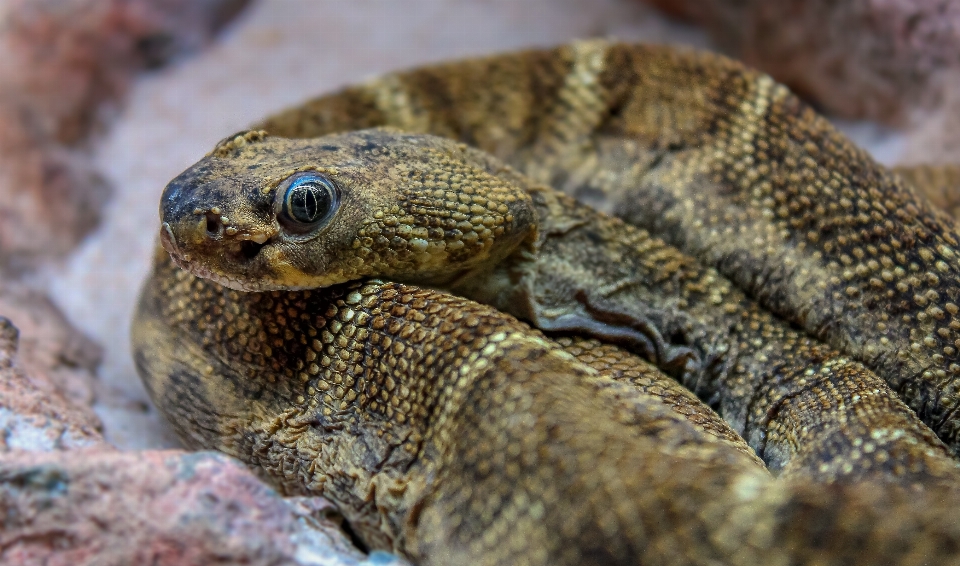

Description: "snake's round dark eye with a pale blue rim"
277 171 340 234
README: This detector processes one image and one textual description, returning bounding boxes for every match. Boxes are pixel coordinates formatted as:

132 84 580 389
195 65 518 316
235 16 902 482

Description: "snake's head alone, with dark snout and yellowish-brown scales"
160 129 537 291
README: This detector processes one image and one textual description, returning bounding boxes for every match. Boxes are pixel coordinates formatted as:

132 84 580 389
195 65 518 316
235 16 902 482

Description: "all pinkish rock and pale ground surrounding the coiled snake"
0 0 960 564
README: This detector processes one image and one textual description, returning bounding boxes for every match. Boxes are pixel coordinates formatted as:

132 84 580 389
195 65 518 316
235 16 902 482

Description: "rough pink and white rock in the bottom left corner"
0 448 390 566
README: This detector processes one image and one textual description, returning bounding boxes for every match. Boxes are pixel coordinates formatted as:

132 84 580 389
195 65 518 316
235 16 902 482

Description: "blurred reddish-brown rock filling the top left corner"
0 0 247 267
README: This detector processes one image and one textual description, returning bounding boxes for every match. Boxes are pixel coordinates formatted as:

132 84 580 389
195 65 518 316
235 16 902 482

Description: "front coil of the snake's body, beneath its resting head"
132 250 960 566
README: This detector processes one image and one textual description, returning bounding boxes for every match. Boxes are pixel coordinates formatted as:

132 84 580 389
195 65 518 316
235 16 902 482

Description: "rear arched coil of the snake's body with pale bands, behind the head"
244 40 960 454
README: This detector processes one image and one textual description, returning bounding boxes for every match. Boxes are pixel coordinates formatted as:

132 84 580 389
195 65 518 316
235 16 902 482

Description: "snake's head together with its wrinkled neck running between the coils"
160 130 960 487
